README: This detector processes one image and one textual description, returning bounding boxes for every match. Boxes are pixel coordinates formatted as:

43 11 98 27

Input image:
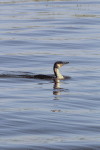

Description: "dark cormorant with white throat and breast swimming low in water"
33 61 69 79
